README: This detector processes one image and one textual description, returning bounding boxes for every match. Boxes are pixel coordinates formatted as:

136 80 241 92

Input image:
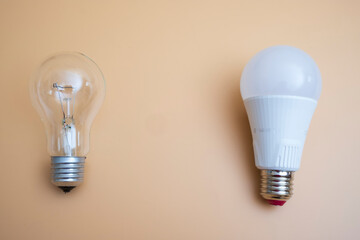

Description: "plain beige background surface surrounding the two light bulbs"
0 0 360 240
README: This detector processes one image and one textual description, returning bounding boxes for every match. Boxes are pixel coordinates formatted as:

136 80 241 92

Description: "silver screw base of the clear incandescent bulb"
51 156 86 192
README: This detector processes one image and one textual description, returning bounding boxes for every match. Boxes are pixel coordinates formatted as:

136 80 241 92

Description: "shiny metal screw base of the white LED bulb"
260 170 294 201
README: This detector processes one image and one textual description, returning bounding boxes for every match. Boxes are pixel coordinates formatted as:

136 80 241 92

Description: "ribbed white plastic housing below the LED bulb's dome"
245 96 317 171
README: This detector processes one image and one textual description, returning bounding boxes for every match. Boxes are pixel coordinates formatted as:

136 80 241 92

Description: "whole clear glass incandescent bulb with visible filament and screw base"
30 53 105 193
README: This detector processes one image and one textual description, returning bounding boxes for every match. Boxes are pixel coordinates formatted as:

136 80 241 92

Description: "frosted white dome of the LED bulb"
240 46 321 100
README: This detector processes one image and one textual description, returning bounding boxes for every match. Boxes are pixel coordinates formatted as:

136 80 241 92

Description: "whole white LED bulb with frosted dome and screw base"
240 46 321 206
